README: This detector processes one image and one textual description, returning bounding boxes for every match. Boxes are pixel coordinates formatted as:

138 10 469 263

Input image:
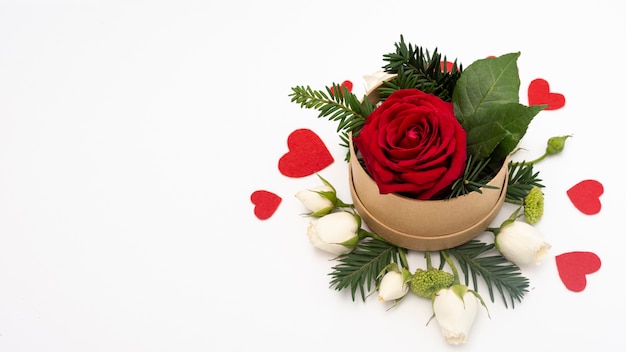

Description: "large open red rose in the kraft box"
354 89 466 199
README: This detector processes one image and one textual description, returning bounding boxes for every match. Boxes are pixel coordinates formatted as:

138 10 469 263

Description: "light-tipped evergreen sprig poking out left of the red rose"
289 83 374 147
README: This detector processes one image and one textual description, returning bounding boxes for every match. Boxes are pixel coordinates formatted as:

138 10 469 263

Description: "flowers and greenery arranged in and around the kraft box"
290 36 570 344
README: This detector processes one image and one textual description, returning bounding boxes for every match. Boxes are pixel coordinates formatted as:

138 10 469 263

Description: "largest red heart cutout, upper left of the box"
278 128 335 177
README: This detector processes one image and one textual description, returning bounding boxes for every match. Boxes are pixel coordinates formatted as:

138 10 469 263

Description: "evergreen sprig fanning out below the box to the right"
447 240 529 308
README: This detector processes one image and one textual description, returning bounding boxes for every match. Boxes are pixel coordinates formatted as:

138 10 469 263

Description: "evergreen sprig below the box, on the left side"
329 238 404 301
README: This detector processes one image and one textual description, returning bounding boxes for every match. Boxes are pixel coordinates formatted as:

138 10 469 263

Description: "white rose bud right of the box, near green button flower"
495 221 552 266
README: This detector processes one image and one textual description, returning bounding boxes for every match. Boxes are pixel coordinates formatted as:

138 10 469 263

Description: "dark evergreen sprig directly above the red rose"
380 36 463 101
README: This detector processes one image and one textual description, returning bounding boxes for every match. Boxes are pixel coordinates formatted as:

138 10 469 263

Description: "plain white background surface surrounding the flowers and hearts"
0 0 626 352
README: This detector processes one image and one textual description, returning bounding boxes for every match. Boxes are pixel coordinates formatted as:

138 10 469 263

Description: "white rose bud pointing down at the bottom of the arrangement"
433 285 479 345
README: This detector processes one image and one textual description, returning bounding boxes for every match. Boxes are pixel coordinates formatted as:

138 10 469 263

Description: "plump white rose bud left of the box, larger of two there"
307 211 361 255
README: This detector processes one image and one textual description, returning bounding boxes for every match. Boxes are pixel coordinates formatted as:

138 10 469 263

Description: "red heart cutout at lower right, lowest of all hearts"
555 252 602 292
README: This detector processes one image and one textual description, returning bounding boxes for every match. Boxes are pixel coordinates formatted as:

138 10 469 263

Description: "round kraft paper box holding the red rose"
349 139 507 251
